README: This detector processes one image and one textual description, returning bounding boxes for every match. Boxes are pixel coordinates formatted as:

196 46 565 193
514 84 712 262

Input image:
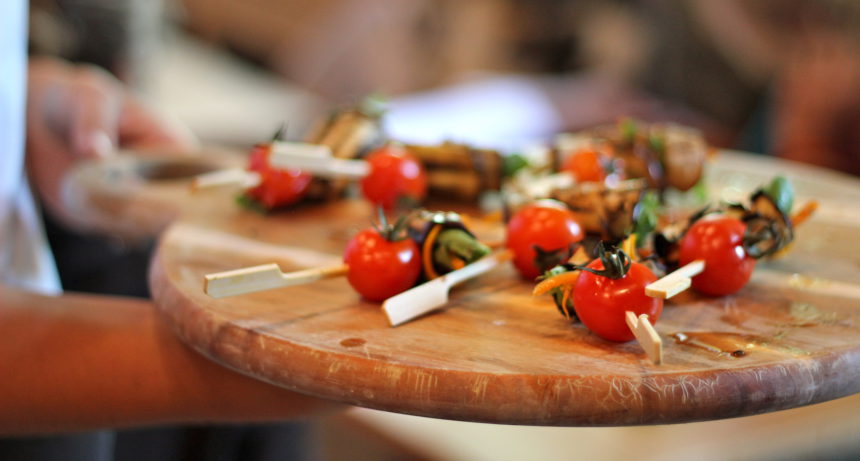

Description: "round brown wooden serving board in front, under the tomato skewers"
151 154 860 426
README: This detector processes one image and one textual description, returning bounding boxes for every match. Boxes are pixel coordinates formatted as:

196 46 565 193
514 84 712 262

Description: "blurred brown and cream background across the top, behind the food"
31 0 860 174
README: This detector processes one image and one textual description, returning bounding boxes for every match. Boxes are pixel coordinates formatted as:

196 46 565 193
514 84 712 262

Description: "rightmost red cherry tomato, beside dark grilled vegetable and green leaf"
679 216 755 296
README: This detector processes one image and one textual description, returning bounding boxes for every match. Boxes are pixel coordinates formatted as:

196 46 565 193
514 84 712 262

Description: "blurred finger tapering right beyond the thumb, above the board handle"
119 96 198 155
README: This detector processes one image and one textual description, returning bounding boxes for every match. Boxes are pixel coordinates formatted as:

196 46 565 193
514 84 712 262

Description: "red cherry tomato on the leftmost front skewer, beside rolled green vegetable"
343 229 421 301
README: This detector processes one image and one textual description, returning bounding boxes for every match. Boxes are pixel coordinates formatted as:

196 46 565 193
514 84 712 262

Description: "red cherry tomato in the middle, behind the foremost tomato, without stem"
506 200 583 280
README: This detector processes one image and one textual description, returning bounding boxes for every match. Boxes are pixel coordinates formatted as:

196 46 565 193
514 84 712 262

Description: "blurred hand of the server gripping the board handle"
27 58 194 224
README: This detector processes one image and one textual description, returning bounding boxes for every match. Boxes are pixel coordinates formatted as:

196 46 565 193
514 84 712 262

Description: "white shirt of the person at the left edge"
0 0 60 293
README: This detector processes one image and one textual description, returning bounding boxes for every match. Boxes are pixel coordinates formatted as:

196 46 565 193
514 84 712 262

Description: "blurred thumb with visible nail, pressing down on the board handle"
67 67 123 158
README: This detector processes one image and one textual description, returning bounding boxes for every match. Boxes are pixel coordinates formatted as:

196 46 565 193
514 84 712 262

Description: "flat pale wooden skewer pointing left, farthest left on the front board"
203 263 349 298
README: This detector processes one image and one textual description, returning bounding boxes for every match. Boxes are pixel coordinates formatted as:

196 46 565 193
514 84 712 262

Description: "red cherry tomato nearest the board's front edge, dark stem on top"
573 259 663 341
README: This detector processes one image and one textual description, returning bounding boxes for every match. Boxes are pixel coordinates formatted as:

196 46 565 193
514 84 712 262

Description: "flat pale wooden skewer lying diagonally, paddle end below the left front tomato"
382 250 513 327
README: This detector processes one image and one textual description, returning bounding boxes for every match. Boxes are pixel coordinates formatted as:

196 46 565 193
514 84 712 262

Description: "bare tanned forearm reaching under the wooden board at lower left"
0 287 336 434
